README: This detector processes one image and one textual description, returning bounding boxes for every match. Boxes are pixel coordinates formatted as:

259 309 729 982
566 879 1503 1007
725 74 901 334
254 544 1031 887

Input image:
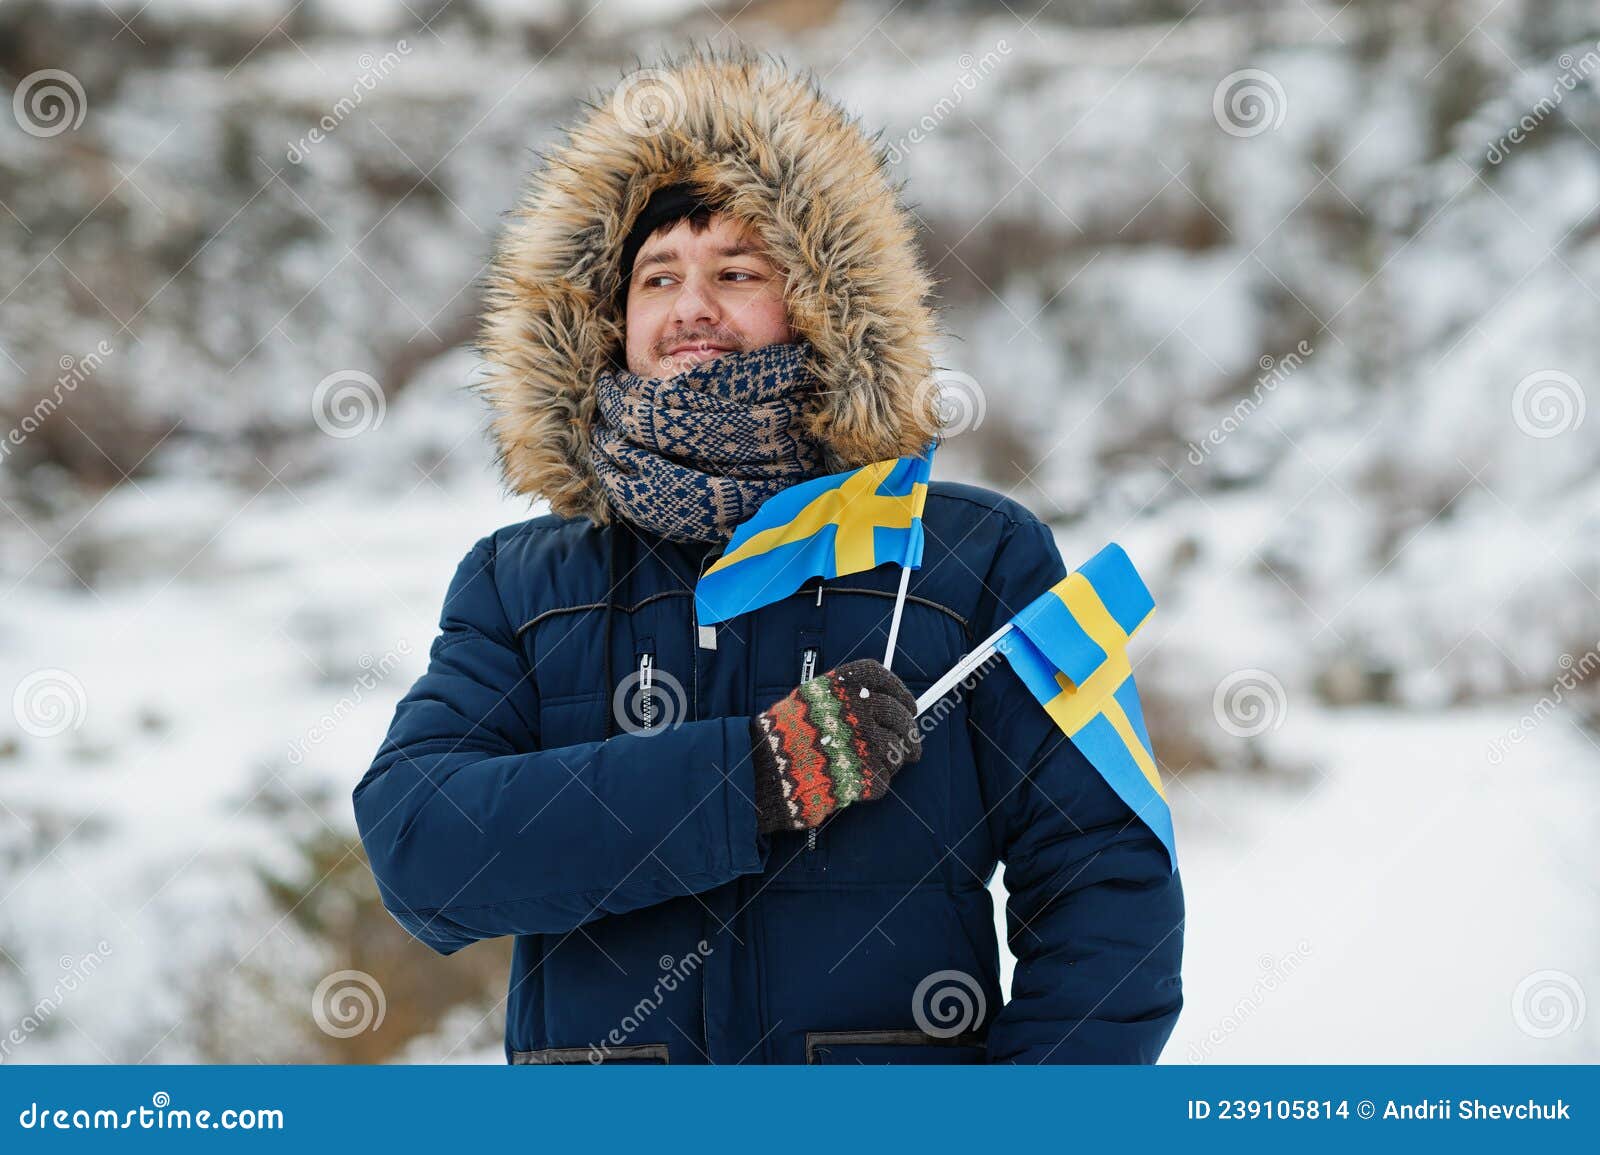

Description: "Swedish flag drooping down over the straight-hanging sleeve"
995 544 1178 869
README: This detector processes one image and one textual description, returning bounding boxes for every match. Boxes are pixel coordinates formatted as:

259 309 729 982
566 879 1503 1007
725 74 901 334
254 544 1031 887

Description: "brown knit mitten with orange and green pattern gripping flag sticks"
750 657 922 833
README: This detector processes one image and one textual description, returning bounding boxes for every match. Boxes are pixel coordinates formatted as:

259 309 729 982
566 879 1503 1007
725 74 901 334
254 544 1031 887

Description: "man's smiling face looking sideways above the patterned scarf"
626 213 792 378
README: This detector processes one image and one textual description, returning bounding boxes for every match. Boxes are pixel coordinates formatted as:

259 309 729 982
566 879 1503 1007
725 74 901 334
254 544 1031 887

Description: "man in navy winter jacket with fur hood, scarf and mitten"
355 51 1184 1064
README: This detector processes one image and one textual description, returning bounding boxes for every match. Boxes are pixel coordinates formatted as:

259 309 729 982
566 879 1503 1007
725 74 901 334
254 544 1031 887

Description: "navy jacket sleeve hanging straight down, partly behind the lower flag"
968 507 1184 1064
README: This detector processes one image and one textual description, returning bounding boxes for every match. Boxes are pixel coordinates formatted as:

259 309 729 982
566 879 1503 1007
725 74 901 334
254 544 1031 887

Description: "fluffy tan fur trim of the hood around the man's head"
478 48 939 525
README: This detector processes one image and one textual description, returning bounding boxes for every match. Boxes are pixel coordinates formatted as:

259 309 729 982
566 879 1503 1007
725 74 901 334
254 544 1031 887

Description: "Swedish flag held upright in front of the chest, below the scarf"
694 446 933 625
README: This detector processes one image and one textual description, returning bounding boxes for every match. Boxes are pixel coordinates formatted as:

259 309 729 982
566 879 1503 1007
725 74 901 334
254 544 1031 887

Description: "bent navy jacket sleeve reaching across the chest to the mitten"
354 534 770 955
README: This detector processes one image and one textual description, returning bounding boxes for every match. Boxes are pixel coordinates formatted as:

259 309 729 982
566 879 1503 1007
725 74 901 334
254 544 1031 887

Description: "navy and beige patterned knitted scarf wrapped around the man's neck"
592 341 822 542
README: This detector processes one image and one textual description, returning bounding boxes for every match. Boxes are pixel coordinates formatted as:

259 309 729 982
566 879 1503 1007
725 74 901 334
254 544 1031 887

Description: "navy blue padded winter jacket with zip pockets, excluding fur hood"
355 482 1184 1064
